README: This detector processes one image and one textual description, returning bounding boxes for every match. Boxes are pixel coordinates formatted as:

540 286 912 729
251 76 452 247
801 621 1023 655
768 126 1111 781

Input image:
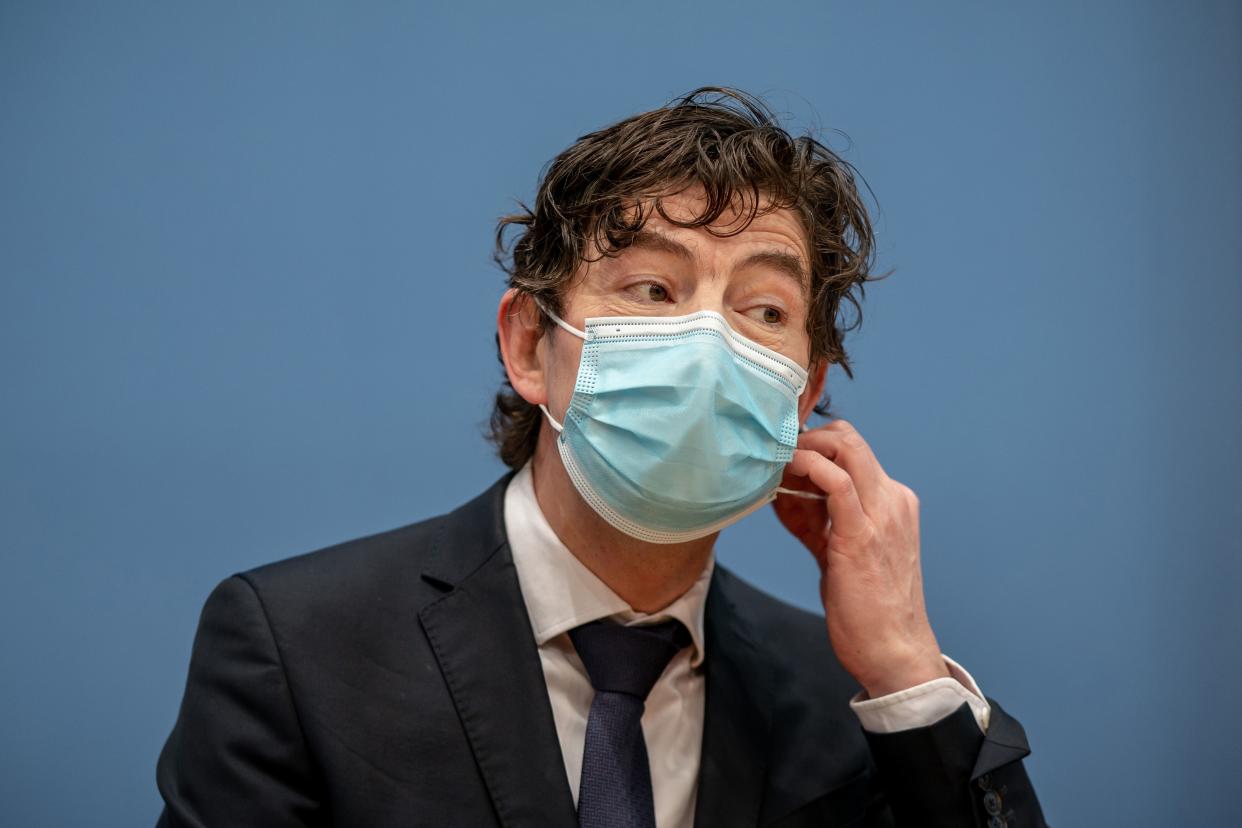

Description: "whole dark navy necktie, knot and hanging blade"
569 619 691 828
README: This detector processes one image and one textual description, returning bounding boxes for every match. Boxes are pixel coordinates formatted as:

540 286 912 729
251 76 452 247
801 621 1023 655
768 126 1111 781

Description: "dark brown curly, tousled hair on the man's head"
491 87 888 468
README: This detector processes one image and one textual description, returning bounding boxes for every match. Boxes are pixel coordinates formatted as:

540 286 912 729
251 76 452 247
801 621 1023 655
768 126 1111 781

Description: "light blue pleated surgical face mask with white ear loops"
539 297 822 544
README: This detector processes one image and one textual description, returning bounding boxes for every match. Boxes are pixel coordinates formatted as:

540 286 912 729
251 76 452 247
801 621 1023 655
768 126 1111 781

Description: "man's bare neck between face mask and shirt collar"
532 422 715 612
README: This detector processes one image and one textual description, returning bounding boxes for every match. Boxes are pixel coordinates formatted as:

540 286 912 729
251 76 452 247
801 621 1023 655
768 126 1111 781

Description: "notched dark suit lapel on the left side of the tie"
419 477 578 828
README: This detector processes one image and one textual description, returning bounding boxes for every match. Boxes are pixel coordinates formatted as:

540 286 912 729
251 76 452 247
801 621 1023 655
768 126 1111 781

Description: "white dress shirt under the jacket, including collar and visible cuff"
504 463 989 828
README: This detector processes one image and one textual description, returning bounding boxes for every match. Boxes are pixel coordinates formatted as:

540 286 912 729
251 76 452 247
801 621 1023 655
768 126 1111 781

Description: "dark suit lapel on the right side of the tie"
694 566 771 828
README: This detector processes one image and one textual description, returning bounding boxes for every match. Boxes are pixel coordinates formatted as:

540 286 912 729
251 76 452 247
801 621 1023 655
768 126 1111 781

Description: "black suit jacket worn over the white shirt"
156 475 1043 828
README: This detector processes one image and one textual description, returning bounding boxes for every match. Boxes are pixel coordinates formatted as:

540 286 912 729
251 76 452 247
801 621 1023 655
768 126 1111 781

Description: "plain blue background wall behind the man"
0 1 1242 827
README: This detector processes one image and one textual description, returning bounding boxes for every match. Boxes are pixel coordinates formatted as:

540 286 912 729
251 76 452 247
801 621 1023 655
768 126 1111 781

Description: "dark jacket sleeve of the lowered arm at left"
155 575 327 828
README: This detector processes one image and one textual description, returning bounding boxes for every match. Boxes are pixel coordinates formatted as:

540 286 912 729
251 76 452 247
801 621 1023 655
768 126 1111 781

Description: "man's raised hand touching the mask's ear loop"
773 420 949 698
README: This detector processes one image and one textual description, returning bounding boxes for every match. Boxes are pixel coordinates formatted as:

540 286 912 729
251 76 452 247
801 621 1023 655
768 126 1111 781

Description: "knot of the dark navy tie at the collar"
569 618 691 701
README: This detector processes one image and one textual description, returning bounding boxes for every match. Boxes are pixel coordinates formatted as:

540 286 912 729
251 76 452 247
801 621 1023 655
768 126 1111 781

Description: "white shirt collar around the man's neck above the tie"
504 462 715 667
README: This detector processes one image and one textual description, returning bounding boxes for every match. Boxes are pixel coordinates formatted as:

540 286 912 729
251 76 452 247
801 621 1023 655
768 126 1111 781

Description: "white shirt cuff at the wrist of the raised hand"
850 653 991 734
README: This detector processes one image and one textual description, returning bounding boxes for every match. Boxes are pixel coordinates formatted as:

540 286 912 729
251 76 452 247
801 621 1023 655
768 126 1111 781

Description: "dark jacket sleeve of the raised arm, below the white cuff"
864 698 1047 828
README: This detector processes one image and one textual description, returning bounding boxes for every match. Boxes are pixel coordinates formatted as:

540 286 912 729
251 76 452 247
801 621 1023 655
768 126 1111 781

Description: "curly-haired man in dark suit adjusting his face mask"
158 88 1043 828
